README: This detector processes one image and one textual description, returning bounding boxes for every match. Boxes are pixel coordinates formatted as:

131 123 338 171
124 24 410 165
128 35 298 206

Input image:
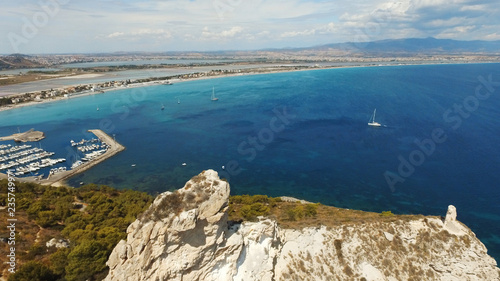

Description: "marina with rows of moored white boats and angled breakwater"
0 130 125 185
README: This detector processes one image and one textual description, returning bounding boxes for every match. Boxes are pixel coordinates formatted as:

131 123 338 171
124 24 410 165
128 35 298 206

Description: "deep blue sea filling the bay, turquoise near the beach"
0 64 500 260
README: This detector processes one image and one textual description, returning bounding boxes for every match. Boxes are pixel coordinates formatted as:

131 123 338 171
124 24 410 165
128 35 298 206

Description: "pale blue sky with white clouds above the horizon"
0 0 500 54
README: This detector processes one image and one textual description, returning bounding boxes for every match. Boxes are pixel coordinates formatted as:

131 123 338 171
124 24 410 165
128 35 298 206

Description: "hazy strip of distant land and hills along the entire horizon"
0 37 500 70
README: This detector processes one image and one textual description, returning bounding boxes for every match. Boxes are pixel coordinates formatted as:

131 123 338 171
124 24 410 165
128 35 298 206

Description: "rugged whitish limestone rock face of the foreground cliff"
105 170 500 281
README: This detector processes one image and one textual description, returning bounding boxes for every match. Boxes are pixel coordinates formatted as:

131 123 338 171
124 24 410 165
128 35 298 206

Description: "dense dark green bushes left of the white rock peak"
0 180 152 281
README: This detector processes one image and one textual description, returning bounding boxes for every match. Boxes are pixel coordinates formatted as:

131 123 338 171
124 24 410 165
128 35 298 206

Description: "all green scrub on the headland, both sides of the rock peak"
0 180 422 281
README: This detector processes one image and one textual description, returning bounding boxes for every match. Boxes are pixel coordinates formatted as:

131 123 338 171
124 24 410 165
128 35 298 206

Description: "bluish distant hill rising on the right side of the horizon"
310 37 500 55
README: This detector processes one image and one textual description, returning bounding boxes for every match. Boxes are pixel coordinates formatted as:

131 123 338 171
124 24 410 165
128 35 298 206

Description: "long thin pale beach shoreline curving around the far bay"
0 61 499 112
